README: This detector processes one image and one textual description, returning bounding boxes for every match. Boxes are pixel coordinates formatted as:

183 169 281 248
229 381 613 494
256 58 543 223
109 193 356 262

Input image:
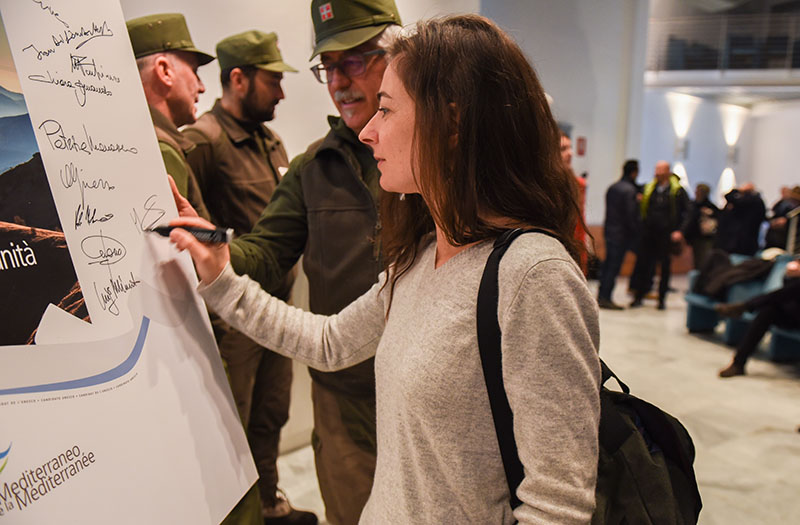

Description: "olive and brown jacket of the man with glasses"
231 117 382 397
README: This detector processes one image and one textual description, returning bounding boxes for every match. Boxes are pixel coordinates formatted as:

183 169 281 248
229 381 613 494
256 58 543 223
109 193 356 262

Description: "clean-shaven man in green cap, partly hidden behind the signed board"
127 13 214 217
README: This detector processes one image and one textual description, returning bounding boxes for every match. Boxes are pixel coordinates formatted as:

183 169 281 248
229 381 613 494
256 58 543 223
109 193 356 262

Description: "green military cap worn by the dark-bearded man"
217 31 297 73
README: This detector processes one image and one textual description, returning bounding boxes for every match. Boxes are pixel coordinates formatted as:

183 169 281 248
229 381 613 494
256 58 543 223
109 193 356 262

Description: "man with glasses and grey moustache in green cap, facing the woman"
173 0 400 525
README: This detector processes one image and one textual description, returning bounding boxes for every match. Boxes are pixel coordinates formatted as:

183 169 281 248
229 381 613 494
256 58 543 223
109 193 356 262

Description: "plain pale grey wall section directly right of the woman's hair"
481 0 649 224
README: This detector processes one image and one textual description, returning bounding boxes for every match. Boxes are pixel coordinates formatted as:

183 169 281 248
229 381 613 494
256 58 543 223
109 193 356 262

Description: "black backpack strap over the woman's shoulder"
478 228 555 508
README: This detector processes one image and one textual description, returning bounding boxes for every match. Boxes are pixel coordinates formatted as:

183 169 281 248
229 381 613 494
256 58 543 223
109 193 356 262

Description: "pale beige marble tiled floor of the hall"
278 277 800 525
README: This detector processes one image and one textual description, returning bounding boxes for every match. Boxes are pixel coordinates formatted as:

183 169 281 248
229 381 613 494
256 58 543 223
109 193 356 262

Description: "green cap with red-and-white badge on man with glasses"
311 0 401 58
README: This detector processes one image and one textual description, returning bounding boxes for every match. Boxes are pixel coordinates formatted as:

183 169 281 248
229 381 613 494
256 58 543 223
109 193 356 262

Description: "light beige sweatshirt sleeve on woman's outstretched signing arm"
198 264 385 371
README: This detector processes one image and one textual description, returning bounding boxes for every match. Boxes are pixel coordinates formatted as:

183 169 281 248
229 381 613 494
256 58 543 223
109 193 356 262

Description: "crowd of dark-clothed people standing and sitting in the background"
597 159 800 378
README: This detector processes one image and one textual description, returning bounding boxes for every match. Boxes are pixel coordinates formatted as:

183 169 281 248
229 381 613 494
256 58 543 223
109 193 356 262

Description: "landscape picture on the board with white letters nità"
0 14 89 346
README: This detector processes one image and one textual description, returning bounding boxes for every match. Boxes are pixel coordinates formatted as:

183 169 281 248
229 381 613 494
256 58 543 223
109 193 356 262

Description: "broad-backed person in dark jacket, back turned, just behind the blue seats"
714 183 767 255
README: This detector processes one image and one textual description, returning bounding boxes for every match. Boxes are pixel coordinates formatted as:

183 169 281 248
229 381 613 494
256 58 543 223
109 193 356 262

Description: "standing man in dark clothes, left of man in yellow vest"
597 160 639 310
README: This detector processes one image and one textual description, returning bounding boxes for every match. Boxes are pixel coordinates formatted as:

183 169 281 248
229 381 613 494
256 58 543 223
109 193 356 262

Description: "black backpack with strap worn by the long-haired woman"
477 229 702 525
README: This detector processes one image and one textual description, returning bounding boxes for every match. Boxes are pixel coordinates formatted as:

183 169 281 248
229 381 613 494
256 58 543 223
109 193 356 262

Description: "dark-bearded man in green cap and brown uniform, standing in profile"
183 31 317 525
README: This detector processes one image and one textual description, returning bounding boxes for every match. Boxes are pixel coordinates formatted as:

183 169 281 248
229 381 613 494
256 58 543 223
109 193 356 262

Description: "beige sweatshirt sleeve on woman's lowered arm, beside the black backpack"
499 259 600 524
